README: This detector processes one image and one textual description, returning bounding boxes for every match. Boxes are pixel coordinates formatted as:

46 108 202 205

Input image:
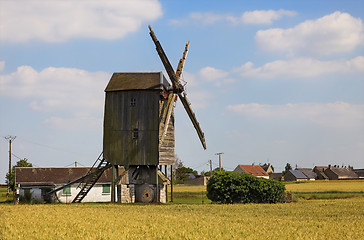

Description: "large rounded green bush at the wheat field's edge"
207 171 286 203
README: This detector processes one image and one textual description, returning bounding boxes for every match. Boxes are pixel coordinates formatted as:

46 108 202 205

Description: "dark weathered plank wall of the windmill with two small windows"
104 91 159 165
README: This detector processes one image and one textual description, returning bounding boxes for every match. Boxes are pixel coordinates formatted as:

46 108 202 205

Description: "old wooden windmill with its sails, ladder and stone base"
47 26 206 202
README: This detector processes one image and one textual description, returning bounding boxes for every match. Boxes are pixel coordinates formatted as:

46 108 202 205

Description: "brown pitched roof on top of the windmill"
105 72 170 92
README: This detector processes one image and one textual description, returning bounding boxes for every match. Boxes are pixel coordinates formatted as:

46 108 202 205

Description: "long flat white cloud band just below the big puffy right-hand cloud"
234 56 364 79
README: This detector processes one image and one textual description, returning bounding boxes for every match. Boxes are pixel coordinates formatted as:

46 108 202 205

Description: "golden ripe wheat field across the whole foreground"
0 197 364 239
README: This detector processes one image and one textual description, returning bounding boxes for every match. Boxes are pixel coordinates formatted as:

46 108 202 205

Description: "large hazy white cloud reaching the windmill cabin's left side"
0 66 110 127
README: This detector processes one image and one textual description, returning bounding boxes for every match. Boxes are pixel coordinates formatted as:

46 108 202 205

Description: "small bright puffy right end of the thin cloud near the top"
240 9 296 24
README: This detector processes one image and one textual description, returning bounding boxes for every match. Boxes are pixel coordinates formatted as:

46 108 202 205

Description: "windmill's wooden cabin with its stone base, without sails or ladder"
103 72 174 202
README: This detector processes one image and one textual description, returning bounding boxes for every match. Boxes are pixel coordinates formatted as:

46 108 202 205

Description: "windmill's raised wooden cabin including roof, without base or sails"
103 72 174 166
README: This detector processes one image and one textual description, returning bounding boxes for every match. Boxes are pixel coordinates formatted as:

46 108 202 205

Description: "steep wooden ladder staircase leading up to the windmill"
72 159 112 203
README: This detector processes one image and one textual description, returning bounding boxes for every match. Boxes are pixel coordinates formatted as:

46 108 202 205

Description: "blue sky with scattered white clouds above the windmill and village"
0 0 364 182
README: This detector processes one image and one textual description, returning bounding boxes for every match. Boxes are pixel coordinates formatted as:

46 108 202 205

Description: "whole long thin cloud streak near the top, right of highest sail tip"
170 9 296 25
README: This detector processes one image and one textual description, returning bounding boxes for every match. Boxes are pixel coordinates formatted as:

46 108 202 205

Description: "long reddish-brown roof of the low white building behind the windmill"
15 167 119 186
